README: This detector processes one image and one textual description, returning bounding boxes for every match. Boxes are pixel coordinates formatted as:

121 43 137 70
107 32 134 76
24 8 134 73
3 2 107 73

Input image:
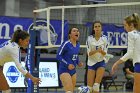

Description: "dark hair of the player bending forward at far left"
11 29 30 43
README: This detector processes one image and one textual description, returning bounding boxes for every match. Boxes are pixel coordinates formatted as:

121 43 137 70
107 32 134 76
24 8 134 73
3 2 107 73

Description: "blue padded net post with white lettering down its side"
26 7 40 93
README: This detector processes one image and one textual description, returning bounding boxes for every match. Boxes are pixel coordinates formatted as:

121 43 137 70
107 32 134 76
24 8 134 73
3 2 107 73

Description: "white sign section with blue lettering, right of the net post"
39 62 59 87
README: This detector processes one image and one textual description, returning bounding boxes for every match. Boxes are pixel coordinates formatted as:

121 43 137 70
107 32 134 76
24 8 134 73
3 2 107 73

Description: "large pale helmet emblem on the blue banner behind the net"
28 20 58 45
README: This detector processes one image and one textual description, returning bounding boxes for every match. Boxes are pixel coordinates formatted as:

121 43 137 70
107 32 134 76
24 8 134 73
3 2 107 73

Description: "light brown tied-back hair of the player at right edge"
124 13 140 30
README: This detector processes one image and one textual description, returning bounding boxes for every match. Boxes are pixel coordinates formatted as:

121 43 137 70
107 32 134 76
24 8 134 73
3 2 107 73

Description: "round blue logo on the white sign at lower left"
6 66 19 83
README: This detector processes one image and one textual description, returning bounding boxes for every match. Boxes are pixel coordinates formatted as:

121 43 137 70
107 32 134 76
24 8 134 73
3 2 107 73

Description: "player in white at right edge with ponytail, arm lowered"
112 13 140 93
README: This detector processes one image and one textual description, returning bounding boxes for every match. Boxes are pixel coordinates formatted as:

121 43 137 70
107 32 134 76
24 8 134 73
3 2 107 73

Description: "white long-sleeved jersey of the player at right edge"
121 30 140 65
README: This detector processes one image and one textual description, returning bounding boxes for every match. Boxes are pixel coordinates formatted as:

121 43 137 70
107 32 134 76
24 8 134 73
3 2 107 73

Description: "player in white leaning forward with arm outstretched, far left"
0 30 40 93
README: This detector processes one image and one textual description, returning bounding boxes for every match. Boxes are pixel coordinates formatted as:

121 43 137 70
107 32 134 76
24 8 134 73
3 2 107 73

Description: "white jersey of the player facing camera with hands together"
86 35 108 66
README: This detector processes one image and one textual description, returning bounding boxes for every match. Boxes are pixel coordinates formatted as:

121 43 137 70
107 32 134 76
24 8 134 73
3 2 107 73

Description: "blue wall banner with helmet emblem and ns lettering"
0 16 68 45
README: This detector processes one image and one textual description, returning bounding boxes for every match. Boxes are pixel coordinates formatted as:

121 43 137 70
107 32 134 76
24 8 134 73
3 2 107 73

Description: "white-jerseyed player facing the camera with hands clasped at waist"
87 21 108 93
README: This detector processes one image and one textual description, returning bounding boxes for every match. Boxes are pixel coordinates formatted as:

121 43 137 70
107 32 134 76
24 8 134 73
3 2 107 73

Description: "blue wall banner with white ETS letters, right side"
86 23 127 46
